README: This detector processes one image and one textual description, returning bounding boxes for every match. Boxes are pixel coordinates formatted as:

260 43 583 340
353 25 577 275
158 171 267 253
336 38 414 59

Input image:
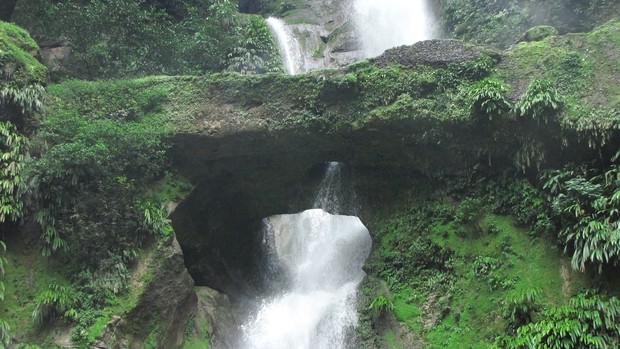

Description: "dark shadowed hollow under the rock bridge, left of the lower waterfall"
170 158 357 300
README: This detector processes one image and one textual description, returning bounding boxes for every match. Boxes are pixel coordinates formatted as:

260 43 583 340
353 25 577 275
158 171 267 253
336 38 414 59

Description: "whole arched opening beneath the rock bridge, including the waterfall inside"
172 158 372 349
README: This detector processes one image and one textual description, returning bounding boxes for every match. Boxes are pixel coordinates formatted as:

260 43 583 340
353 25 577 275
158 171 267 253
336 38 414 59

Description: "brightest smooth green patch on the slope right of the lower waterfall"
426 215 587 349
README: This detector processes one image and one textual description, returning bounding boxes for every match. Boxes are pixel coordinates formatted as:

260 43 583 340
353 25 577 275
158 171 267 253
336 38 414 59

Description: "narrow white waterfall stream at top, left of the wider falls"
267 17 306 74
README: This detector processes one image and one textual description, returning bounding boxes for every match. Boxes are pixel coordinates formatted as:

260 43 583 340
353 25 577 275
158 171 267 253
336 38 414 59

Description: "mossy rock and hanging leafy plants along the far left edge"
0 22 46 348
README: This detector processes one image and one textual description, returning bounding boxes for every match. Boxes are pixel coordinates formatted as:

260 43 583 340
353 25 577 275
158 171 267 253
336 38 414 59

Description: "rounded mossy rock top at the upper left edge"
0 21 47 89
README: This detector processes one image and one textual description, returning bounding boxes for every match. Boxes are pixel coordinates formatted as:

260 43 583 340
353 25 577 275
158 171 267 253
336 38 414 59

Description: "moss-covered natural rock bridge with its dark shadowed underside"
35 21 619 302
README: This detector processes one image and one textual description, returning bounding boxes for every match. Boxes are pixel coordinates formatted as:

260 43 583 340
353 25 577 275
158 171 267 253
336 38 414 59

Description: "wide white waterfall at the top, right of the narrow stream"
354 0 435 57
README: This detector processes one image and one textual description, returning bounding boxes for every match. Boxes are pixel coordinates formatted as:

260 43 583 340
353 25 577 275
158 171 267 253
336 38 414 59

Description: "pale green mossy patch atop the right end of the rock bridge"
498 19 620 144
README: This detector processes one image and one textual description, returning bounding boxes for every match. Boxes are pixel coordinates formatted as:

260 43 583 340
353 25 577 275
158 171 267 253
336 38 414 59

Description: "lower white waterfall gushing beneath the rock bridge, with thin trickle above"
242 163 372 349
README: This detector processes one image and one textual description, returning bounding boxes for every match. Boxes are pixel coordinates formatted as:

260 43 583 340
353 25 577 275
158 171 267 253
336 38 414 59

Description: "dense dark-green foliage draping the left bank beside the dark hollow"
6 77 182 344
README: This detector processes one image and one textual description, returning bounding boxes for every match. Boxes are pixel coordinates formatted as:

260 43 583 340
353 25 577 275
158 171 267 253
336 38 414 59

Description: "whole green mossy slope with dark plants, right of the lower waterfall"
367 184 593 349
